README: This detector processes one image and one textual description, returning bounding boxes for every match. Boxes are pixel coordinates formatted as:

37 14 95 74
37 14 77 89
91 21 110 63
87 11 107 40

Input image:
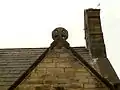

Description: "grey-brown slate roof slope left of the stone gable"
0 48 46 87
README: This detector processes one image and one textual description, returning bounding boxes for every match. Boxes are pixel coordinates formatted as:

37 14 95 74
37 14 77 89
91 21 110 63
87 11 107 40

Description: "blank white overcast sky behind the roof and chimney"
0 0 120 77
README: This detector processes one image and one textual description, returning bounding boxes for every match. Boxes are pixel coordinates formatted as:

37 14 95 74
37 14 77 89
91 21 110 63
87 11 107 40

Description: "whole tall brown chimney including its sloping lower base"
84 9 120 83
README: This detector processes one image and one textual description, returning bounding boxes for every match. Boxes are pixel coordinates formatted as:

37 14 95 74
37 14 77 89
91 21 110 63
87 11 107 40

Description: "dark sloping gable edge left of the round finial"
8 48 49 90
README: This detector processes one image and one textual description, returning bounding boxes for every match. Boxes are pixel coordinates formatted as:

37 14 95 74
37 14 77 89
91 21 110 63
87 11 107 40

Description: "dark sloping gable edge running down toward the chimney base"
70 47 115 90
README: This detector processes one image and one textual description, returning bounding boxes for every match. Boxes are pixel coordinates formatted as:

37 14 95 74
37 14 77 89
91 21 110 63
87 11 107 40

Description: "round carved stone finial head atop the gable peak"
52 27 68 40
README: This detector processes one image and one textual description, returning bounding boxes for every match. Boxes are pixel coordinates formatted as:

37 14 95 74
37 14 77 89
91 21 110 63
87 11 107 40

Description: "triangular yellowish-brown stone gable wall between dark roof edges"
16 48 108 90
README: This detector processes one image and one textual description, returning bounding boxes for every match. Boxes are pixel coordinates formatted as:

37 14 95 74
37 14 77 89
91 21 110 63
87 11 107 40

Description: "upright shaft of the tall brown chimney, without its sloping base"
84 9 107 58
